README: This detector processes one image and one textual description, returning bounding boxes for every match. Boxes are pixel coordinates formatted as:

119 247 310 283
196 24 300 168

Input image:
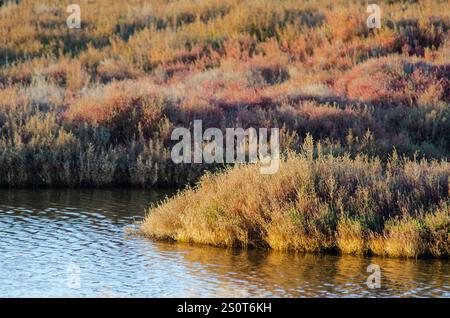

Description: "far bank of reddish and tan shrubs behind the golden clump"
0 0 450 187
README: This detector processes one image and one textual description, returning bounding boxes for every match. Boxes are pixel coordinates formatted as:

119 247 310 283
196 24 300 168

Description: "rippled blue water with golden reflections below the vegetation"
0 190 450 297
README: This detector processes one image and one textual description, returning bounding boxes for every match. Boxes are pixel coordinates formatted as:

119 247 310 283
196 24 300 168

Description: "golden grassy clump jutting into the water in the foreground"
141 138 450 257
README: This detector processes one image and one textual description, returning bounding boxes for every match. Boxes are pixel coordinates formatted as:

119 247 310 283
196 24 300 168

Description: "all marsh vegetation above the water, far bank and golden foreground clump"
0 0 450 257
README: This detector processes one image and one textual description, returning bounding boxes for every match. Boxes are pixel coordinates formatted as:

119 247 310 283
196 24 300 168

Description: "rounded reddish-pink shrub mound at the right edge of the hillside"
335 57 449 106
